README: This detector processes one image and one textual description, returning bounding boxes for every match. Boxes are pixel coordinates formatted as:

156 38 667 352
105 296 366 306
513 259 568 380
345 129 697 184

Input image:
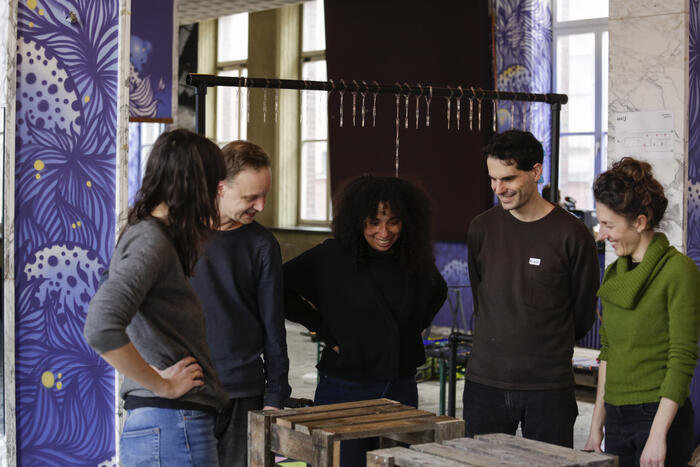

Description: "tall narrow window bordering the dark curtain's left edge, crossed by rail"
299 0 330 223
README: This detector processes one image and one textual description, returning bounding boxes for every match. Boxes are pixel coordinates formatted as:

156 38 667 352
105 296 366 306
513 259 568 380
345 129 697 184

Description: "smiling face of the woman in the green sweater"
595 201 647 263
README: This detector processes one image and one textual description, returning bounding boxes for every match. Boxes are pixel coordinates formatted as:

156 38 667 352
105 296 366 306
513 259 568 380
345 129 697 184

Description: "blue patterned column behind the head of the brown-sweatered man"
494 0 552 186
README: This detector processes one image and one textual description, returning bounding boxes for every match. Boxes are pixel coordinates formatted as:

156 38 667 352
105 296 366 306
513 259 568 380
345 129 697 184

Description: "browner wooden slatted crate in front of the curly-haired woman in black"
248 399 464 467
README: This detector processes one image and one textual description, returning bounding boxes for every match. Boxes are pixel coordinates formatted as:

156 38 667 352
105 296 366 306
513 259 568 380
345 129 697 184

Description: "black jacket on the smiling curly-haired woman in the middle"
284 239 447 381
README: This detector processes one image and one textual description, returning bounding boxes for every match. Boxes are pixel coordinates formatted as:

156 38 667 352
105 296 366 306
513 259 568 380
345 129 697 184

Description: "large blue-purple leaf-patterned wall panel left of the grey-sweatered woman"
15 0 119 466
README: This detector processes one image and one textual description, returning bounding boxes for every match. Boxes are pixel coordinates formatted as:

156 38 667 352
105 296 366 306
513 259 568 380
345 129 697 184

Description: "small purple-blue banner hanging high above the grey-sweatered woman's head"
129 0 174 123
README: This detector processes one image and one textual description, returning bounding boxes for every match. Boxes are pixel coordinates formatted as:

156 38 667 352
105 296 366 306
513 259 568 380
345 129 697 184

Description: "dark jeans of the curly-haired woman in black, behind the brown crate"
314 373 418 467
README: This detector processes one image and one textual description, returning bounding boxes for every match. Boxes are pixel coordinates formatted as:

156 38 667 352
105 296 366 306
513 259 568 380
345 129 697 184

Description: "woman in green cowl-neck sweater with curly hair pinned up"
585 157 700 466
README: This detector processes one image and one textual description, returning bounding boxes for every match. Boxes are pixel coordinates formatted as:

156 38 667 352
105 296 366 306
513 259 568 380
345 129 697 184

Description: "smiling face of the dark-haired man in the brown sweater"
486 156 542 212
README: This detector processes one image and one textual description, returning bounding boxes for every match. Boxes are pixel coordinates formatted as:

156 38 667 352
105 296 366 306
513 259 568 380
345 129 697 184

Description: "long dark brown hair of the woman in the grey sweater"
127 129 226 276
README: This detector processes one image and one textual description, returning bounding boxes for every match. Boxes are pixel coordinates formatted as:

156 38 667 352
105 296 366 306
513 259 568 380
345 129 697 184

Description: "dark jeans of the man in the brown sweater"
464 381 578 448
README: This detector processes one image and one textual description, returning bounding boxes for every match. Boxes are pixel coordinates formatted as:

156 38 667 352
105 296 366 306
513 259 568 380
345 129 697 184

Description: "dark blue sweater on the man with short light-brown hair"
191 222 291 407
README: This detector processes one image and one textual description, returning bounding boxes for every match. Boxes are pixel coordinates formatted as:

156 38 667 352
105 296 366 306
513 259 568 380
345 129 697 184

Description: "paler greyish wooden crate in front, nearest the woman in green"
367 433 618 467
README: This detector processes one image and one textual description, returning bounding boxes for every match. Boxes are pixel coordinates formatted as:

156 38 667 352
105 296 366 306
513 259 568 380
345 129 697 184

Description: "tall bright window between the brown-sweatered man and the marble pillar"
553 0 608 209
